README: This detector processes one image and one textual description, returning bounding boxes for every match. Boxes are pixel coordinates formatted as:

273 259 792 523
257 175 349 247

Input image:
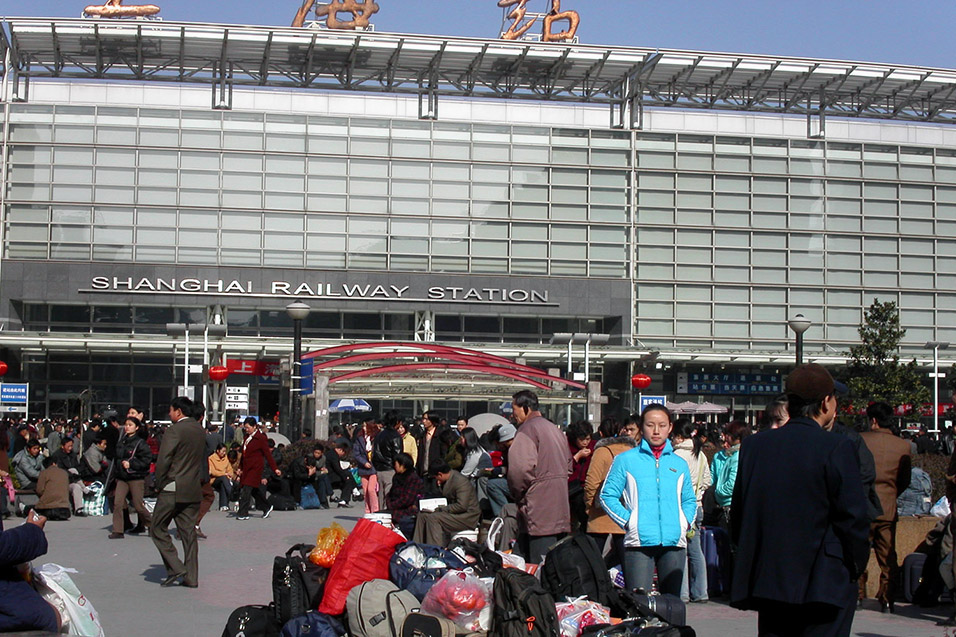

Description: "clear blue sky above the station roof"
7 0 956 69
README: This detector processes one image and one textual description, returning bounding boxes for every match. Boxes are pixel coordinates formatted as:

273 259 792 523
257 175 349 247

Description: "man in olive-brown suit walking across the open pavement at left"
149 396 207 588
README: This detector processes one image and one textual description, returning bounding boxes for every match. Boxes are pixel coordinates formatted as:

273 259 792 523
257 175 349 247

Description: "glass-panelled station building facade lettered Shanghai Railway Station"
0 18 956 416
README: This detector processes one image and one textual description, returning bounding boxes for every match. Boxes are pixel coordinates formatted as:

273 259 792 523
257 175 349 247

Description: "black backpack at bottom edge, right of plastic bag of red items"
490 568 559 637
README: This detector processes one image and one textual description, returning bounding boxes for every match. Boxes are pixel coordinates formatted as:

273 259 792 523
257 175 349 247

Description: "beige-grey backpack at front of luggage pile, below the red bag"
345 579 421 637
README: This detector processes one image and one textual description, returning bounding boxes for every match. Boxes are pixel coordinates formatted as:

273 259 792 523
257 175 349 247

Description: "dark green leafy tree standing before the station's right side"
843 299 931 413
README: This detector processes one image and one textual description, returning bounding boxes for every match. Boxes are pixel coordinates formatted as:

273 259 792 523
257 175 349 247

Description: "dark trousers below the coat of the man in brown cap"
757 584 856 637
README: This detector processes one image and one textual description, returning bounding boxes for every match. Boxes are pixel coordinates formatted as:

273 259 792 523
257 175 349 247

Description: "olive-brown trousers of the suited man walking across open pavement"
149 491 199 584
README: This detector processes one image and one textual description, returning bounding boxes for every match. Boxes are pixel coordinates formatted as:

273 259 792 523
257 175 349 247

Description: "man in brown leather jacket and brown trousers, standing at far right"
860 402 911 613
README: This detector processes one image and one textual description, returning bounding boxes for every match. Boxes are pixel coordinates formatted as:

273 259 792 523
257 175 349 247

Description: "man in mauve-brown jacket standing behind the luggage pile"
508 390 571 564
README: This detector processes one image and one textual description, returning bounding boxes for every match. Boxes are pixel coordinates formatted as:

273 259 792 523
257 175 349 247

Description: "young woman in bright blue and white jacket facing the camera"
600 405 697 595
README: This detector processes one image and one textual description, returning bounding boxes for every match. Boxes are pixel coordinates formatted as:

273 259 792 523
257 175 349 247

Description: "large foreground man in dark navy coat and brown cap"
730 363 870 636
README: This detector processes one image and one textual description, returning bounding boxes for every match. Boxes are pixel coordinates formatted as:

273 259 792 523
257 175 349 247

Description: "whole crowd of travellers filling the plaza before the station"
0 365 956 634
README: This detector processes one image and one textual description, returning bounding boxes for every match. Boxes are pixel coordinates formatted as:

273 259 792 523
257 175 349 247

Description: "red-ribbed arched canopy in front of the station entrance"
302 342 587 403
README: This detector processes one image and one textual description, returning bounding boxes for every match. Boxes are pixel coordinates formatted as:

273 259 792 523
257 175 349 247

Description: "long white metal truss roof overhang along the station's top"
0 18 956 128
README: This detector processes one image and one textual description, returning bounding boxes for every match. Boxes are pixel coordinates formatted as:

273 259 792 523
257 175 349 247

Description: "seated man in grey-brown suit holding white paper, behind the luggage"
414 462 481 546
